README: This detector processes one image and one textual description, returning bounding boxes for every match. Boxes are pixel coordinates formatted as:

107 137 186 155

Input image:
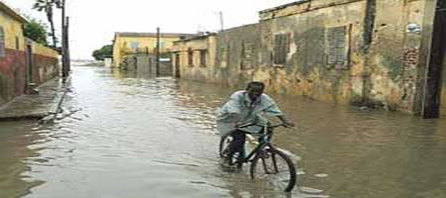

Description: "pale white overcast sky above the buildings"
5 0 295 59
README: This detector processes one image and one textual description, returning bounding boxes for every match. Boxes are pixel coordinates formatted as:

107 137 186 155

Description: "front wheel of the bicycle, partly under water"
250 146 296 192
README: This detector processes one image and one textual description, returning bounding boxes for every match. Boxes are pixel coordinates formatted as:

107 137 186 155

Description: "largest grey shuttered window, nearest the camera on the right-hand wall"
326 26 348 69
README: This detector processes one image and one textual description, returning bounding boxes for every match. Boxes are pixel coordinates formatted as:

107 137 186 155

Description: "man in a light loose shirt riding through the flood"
217 81 294 165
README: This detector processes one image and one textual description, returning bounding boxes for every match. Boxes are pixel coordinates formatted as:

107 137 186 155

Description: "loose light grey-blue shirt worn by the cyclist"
217 90 283 136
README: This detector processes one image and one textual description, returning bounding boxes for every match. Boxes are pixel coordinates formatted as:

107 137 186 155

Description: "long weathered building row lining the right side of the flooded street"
172 0 446 117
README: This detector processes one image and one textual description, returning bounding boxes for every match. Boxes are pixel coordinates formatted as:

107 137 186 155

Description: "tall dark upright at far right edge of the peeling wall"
422 0 446 118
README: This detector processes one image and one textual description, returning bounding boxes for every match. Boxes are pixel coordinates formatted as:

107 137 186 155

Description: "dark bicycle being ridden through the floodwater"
219 123 297 192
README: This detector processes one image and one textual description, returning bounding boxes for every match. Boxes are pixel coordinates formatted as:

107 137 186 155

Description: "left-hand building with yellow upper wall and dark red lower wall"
0 2 59 105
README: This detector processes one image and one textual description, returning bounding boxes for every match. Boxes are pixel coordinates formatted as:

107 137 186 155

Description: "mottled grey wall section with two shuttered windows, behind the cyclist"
213 2 365 103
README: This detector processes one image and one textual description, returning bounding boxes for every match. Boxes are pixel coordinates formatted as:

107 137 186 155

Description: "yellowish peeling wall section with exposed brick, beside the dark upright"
364 0 423 112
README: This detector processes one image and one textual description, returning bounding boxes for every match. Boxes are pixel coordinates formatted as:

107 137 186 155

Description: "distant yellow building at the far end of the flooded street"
113 32 195 67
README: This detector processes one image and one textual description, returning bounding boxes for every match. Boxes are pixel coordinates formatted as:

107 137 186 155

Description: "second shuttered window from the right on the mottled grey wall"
274 33 290 65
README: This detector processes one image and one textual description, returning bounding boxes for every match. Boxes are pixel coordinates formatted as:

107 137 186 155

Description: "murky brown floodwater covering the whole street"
0 67 446 198
